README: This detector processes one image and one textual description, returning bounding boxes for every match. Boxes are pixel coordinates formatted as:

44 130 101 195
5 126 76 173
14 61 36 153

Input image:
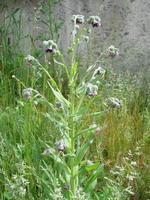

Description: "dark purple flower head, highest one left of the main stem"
43 40 57 53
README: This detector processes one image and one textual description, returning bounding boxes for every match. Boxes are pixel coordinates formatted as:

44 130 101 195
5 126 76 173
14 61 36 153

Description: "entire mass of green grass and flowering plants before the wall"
0 1 150 200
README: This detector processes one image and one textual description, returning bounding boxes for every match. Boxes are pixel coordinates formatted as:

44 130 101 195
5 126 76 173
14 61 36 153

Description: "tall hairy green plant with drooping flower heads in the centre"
12 15 119 199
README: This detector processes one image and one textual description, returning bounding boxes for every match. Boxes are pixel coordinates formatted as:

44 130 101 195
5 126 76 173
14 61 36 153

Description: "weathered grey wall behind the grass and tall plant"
0 0 150 69
